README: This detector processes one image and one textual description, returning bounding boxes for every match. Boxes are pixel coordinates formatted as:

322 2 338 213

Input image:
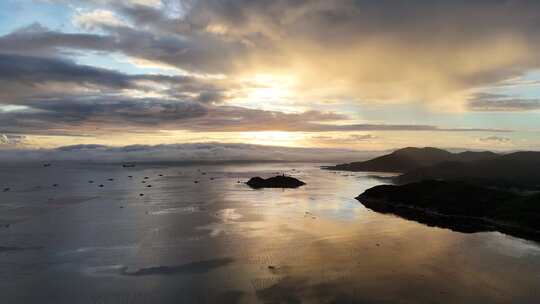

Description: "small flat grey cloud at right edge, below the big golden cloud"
468 93 540 112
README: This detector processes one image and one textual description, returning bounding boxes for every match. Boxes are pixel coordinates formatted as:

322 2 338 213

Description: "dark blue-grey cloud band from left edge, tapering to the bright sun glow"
0 54 232 104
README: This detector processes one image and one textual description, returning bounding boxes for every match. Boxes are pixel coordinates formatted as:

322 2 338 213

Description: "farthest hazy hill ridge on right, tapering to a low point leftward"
324 147 497 172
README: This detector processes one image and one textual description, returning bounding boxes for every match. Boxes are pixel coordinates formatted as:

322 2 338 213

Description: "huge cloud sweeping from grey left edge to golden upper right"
5 0 540 104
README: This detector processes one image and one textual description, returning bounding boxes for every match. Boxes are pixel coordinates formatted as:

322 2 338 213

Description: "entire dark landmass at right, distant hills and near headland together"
327 148 540 240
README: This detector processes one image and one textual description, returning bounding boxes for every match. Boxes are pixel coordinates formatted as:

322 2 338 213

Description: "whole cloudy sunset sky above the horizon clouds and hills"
0 0 540 151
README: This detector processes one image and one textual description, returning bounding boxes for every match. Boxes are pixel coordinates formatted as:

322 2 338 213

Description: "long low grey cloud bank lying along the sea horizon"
0 143 376 162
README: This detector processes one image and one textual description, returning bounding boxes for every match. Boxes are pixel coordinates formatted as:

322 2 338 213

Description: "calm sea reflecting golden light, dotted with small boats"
0 163 540 304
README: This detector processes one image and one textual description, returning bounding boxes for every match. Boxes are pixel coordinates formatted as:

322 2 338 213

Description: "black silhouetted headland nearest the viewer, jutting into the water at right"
356 180 540 240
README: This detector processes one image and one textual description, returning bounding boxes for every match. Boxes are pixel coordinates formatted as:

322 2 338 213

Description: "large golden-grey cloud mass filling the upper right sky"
113 0 540 103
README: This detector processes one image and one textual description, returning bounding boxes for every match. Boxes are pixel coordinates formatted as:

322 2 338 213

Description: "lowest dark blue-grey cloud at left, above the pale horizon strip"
0 96 207 135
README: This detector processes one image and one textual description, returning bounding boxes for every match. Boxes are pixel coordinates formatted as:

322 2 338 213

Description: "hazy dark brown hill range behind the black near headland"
326 147 540 189
